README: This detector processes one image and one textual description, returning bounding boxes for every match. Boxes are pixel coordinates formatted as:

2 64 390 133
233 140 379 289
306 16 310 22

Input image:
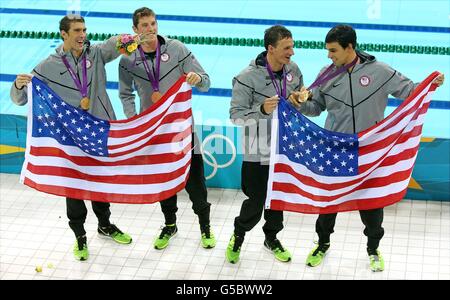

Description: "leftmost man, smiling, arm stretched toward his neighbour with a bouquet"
11 15 132 260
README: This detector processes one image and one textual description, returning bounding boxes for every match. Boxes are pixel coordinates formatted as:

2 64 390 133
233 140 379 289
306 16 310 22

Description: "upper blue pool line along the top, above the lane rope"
0 8 450 33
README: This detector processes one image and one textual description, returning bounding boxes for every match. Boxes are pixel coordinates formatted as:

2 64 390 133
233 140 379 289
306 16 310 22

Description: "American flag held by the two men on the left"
21 76 192 203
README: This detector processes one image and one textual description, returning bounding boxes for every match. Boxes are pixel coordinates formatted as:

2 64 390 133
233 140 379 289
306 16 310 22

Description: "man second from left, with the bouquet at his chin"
119 7 216 249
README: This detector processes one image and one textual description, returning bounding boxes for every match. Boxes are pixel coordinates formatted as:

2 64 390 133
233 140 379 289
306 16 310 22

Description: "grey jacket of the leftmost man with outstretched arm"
10 37 120 120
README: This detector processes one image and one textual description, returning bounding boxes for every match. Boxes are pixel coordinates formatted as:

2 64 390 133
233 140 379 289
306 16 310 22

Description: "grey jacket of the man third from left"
230 52 303 163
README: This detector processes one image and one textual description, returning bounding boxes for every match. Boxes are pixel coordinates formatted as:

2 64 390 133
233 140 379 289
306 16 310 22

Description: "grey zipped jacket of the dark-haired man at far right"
299 52 416 133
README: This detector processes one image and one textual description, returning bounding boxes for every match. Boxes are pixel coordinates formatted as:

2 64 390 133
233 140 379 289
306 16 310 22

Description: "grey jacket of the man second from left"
119 35 211 118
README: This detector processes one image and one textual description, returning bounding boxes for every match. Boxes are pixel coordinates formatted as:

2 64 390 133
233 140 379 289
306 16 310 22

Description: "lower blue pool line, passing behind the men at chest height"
0 73 450 110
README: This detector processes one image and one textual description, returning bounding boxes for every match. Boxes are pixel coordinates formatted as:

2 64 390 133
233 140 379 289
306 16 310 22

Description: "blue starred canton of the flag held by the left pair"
32 77 110 156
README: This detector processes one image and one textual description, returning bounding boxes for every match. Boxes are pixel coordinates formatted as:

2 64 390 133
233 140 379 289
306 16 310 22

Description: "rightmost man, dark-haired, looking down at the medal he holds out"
290 25 444 272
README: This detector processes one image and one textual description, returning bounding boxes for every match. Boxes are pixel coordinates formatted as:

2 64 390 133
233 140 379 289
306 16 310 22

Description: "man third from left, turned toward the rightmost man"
225 25 303 263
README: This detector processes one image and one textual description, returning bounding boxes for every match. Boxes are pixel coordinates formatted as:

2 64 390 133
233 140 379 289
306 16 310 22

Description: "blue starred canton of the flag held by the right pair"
278 99 358 176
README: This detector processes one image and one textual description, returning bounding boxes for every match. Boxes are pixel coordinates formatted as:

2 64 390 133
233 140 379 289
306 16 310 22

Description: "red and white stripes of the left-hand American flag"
21 76 192 203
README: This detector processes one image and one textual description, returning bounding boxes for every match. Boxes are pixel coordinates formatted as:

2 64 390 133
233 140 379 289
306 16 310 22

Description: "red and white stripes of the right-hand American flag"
266 72 438 214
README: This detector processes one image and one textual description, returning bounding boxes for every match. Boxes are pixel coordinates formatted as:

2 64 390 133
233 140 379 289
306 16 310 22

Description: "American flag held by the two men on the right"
266 72 439 214
